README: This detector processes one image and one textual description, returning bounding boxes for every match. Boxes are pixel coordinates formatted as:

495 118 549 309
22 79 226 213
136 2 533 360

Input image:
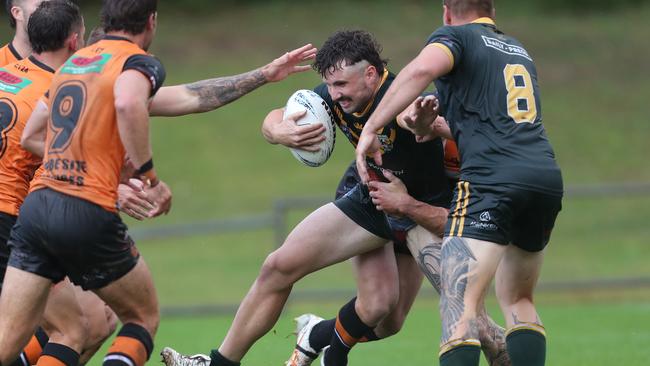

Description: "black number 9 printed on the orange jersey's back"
50 83 86 152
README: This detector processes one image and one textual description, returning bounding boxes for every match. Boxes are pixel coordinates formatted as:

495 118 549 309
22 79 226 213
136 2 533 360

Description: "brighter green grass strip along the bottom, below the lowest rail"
85 294 650 366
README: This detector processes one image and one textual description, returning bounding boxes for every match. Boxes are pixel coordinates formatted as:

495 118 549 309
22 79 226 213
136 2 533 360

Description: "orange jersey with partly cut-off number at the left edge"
0 57 54 216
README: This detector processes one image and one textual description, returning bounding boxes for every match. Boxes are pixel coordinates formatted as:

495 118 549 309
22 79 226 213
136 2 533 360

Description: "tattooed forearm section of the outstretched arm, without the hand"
185 69 268 113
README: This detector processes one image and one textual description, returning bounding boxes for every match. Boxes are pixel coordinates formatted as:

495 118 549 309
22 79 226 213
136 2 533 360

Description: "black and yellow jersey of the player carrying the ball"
314 70 451 207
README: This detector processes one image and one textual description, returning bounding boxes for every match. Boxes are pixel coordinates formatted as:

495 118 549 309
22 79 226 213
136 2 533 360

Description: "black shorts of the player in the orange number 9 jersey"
9 188 140 290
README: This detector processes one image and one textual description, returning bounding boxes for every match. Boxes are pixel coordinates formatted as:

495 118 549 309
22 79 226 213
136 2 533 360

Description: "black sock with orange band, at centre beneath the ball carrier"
326 297 372 366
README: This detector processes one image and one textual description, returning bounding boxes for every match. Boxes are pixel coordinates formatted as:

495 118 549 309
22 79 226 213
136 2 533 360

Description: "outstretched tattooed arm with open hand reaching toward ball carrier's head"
150 44 316 116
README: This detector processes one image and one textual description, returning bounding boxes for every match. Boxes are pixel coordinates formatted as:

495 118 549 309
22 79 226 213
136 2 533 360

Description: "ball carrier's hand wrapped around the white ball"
268 110 325 152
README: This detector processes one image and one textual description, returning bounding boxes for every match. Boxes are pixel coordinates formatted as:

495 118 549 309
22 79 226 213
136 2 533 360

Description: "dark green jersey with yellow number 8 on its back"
427 18 563 195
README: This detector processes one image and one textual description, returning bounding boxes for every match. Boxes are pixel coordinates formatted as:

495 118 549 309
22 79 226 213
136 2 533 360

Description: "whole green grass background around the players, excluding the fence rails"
0 0 650 365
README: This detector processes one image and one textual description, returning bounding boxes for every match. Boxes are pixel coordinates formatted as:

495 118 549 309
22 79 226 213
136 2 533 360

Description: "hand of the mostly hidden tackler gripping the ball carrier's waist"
368 170 412 216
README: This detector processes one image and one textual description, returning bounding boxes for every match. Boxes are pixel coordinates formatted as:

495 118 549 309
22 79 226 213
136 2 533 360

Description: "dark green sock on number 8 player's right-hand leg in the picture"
506 329 546 366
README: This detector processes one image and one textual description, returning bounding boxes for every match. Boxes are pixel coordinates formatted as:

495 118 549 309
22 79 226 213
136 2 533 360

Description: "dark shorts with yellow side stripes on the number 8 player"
445 181 562 252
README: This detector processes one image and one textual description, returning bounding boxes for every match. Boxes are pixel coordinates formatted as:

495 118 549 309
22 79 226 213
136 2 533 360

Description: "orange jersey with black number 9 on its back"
33 36 165 211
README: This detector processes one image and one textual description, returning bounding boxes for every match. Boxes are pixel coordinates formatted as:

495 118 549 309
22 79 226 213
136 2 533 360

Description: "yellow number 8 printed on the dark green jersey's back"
503 64 537 123
